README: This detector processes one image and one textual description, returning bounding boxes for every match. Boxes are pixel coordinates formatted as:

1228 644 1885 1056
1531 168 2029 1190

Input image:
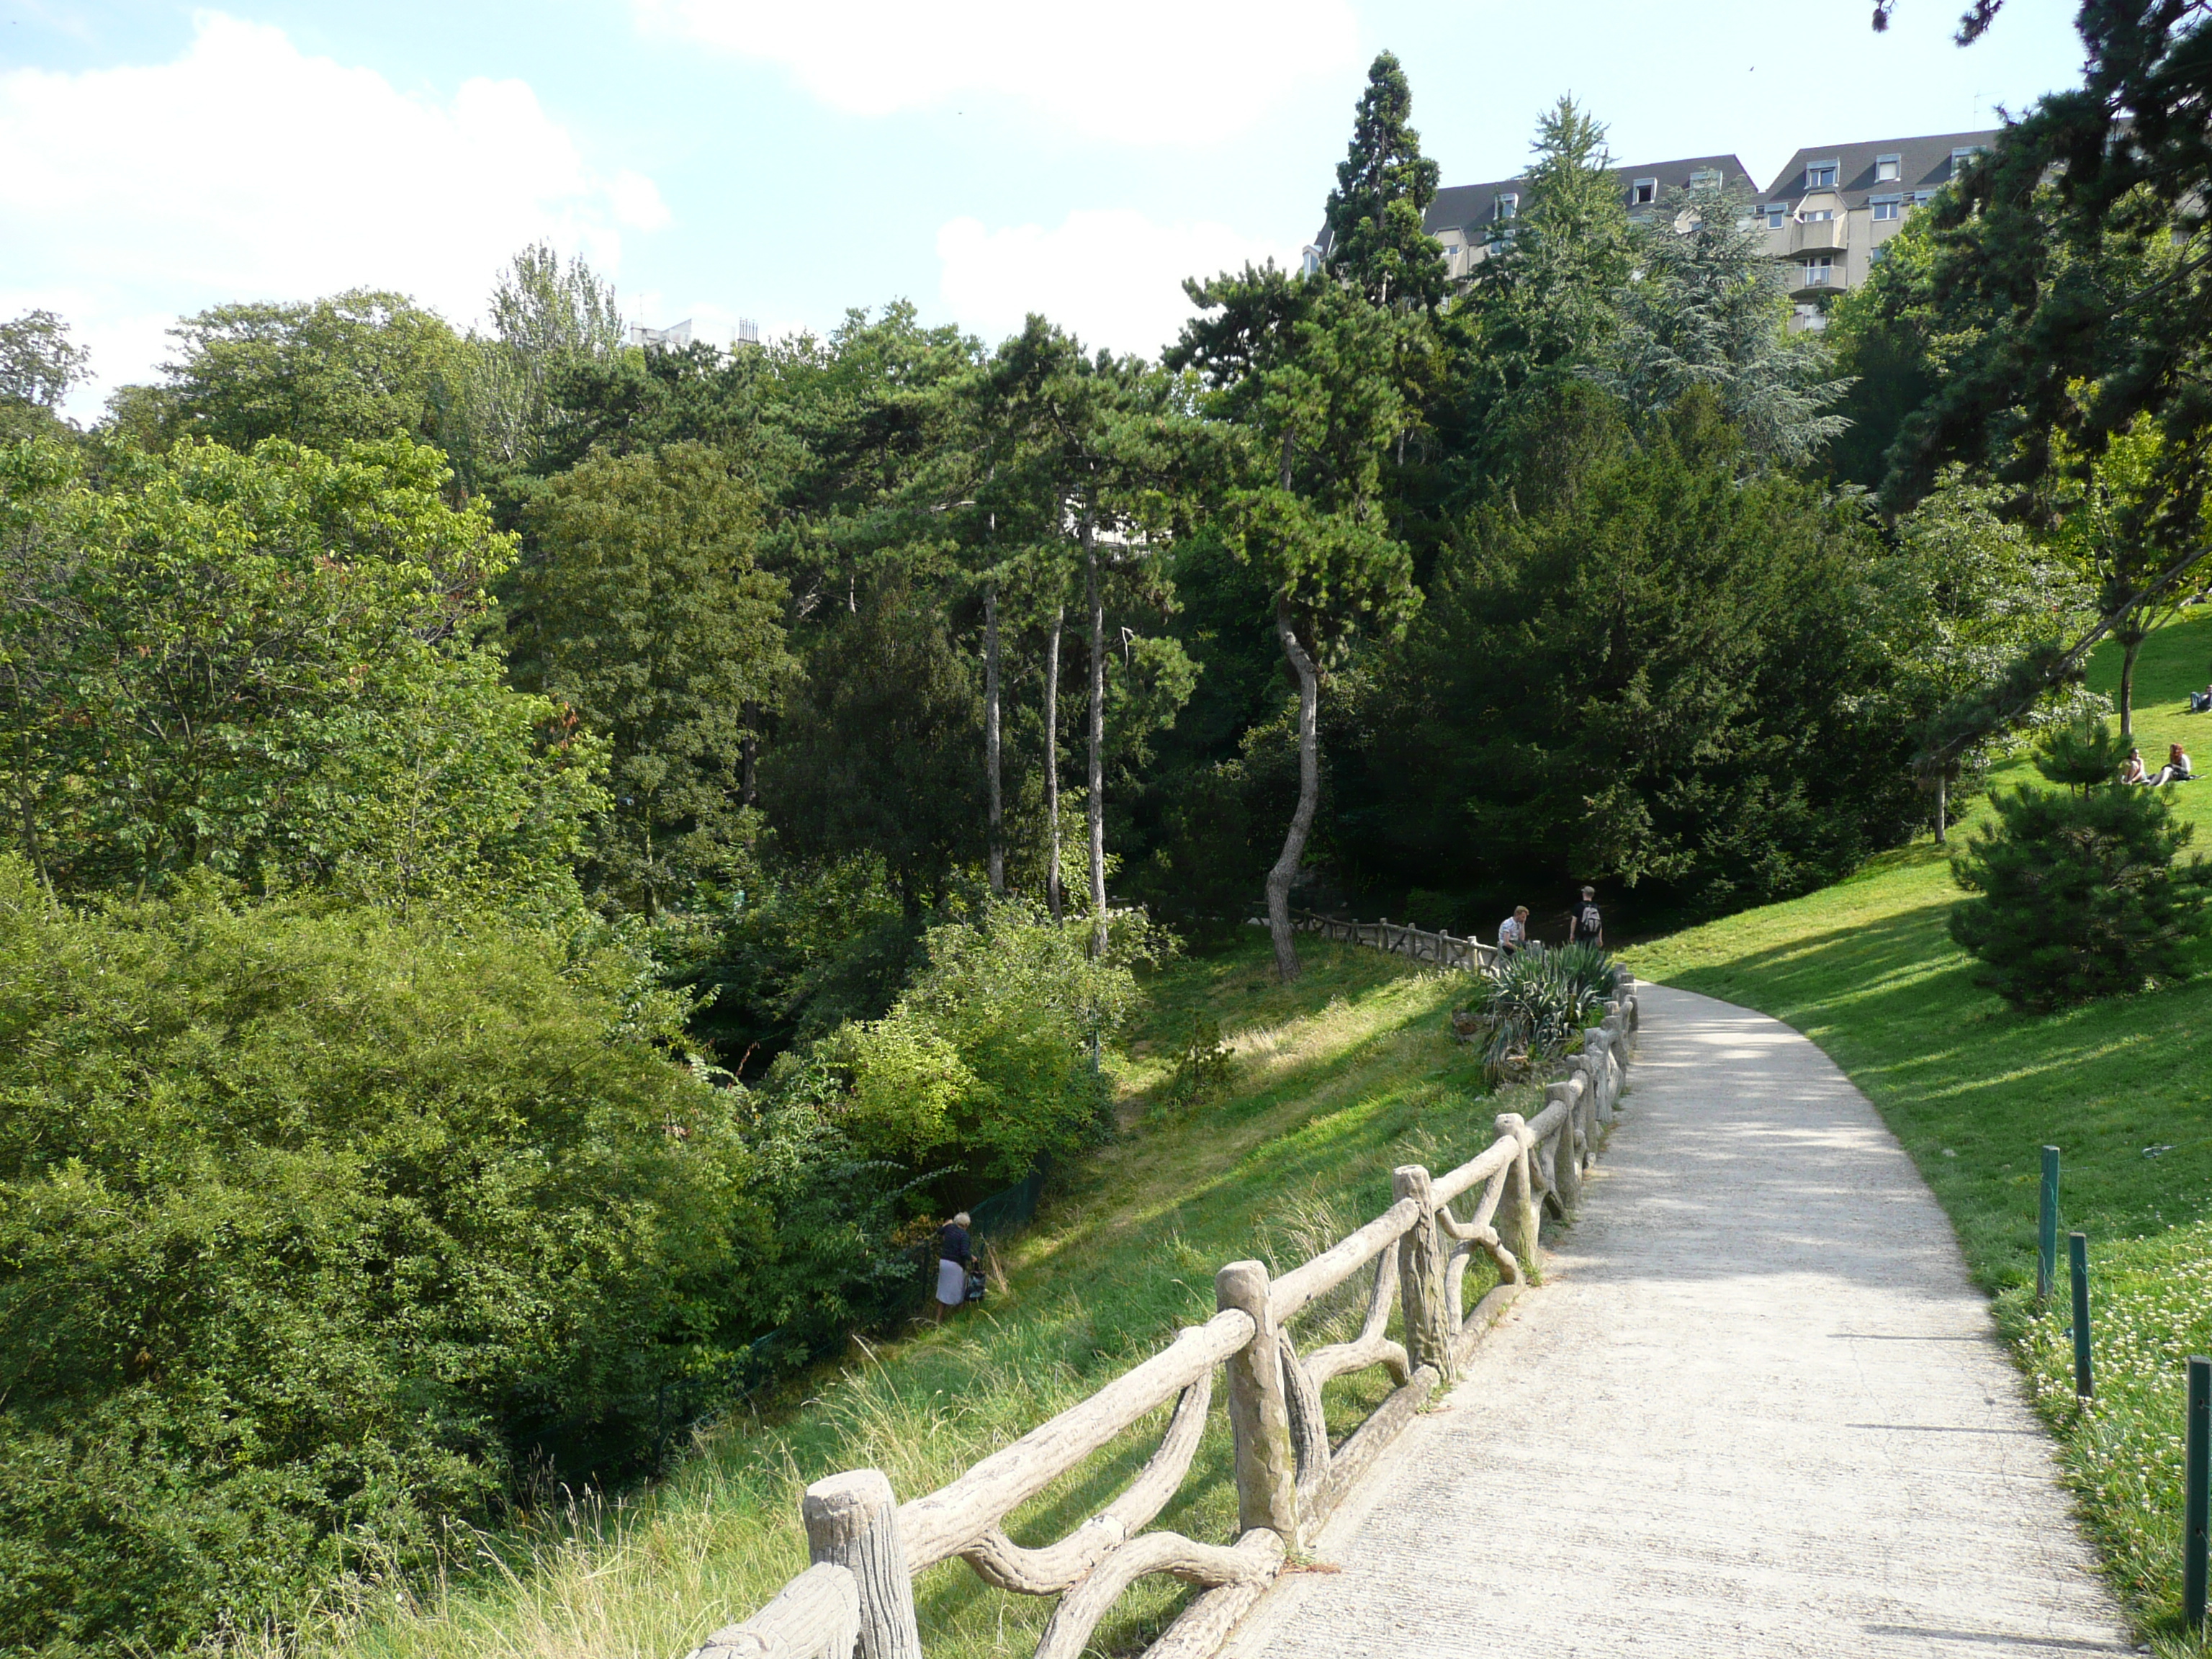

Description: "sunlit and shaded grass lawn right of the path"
1626 611 2212 1655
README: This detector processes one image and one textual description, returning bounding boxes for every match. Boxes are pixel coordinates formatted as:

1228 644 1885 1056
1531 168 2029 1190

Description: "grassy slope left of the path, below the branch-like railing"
301 933 1500 1659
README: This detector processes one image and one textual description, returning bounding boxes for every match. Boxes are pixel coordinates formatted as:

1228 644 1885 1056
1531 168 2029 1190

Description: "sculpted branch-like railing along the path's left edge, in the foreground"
693 971 1637 1659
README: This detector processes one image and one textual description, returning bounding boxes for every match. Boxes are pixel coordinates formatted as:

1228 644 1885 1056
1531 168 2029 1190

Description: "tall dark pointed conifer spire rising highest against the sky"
1327 51 1451 310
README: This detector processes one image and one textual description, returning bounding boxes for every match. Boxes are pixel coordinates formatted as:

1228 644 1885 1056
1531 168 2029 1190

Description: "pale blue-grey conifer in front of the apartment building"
1597 181 1849 467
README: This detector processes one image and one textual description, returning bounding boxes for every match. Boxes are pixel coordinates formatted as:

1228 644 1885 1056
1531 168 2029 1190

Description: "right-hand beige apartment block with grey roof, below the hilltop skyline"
1756 128 1997 328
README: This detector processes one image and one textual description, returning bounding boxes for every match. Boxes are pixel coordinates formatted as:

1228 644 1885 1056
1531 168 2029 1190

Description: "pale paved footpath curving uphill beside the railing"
1228 986 2134 1659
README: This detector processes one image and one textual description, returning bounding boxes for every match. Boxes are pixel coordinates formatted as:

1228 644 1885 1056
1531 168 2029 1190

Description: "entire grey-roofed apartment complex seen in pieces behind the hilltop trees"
1305 130 1995 330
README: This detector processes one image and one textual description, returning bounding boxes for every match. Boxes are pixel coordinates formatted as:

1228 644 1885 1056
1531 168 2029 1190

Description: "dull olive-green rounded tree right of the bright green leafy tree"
513 442 796 916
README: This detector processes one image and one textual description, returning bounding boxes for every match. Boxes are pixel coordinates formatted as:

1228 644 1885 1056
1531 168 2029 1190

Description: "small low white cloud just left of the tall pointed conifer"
938 208 1298 356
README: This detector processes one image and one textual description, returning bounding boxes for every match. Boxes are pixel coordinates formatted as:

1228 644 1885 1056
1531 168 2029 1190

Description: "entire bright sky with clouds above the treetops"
0 0 2082 421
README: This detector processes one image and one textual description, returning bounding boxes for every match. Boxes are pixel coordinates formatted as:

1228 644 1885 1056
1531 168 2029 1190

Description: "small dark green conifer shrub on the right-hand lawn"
1951 719 2212 1011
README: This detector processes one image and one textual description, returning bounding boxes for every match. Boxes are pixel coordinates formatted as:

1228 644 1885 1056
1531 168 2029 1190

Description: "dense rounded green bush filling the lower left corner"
0 858 765 1653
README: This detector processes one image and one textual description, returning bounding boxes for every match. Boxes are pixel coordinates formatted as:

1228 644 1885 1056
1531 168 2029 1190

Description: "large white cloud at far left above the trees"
0 11 670 409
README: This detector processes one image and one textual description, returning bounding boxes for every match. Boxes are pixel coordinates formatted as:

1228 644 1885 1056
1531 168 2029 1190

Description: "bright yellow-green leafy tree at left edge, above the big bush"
0 438 602 904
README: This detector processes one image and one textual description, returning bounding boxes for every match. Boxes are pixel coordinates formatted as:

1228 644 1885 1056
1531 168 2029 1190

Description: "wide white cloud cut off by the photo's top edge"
633 0 1358 144
